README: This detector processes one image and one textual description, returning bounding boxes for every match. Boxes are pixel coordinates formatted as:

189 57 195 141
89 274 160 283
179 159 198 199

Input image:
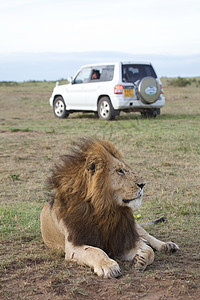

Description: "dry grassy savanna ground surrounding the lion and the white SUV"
0 78 200 299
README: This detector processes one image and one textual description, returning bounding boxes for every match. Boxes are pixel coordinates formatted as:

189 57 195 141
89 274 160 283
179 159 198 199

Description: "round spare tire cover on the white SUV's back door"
138 77 160 104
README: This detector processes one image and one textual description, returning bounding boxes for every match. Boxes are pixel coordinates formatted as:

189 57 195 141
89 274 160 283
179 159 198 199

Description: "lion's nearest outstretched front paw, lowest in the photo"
94 258 122 278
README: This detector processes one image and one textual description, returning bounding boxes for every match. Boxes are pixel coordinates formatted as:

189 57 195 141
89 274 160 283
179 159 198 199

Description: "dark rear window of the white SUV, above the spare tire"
122 64 157 83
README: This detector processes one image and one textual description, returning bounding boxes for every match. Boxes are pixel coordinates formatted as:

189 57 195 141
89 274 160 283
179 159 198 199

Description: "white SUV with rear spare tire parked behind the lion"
50 62 165 120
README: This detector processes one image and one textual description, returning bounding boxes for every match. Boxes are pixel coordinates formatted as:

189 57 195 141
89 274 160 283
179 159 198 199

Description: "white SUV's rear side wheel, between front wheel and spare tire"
98 97 115 120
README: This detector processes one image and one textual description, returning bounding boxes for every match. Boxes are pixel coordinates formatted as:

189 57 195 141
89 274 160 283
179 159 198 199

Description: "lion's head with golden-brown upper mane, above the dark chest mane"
50 140 145 217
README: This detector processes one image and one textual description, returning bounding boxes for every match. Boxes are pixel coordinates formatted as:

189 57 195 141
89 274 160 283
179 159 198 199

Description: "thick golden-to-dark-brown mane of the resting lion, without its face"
49 139 138 257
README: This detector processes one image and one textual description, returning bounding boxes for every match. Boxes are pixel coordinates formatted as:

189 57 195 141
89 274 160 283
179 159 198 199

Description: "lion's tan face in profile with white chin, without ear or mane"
110 158 145 210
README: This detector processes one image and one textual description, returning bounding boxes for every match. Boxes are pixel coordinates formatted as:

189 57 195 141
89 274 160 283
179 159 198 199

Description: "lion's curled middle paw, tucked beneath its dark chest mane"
133 247 154 271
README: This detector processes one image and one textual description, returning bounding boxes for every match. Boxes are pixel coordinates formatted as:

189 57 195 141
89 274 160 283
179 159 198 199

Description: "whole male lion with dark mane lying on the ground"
40 139 179 278
